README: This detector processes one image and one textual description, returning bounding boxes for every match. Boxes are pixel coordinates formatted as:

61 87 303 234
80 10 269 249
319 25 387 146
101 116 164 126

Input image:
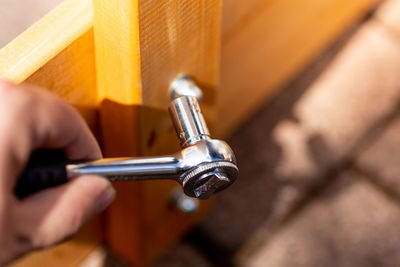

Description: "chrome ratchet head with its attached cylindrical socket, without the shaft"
169 90 238 199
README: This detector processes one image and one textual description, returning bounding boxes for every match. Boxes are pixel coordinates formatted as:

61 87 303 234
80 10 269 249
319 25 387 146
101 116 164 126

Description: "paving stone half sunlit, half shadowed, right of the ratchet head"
201 22 400 252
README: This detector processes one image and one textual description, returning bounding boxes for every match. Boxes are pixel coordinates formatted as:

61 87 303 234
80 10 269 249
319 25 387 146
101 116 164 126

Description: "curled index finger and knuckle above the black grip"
0 82 101 186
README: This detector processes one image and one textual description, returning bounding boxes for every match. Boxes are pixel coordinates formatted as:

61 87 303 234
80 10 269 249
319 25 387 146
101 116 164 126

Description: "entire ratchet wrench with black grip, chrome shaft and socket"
15 85 238 199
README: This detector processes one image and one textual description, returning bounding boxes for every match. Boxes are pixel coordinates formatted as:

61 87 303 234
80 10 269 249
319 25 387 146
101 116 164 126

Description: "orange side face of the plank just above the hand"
24 29 100 133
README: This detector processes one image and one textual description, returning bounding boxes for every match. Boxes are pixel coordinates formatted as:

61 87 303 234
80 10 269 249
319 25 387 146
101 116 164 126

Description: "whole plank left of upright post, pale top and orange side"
0 0 98 134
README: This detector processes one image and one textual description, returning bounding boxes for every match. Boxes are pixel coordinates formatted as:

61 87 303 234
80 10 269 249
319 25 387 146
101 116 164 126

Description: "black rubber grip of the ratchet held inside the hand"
14 149 68 199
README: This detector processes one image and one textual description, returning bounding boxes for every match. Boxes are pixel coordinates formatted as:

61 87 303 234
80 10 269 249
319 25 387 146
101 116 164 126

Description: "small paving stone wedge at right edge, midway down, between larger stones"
357 118 400 196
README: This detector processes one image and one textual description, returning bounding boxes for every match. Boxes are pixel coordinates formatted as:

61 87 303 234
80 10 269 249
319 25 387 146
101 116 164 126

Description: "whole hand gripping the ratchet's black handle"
0 80 115 266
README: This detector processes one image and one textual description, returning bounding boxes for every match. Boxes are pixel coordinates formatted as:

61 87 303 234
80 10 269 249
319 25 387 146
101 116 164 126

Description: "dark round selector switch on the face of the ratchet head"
194 169 230 200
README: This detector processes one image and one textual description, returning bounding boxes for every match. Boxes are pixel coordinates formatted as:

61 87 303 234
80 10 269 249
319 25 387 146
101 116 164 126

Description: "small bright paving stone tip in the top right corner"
375 0 400 37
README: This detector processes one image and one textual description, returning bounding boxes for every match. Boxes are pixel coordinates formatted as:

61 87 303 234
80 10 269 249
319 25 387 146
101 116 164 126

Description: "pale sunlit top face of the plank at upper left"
0 0 93 82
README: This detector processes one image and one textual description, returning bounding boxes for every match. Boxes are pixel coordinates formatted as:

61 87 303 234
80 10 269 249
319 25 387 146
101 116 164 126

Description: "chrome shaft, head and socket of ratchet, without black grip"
67 77 238 199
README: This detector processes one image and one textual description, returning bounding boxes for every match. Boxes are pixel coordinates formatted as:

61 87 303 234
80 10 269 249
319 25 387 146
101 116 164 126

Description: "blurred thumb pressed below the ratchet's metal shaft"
17 176 115 249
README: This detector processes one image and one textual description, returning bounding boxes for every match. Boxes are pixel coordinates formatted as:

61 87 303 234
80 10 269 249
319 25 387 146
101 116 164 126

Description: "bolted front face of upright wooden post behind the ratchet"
139 0 222 259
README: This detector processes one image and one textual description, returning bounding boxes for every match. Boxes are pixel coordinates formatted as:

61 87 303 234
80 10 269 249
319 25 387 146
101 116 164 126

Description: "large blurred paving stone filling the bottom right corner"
244 173 400 267
